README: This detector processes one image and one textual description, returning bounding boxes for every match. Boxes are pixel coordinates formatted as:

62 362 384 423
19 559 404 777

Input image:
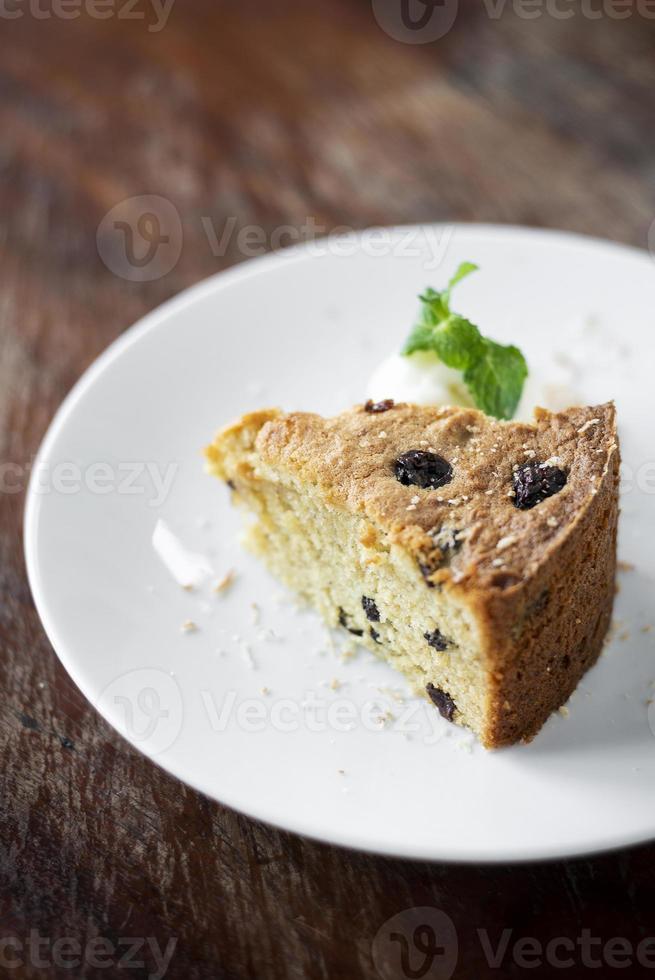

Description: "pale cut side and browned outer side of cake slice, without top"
207 406 619 747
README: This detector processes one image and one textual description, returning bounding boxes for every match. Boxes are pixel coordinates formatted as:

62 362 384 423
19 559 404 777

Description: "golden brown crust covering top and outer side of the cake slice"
208 403 619 746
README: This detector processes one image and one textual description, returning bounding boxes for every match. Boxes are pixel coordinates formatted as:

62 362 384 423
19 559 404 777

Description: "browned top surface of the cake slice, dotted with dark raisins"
249 394 617 588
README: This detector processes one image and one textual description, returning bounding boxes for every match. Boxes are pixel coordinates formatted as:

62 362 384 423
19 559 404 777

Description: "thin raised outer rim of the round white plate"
23 221 655 865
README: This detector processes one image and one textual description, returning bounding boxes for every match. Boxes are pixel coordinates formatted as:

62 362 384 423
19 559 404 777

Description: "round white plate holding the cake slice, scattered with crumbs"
26 226 655 861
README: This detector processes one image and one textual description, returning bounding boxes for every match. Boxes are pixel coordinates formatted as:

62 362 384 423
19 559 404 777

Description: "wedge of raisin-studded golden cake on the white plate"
207 401 619 747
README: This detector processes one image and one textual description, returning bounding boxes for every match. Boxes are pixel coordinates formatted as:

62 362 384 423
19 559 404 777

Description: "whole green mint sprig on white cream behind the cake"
402 262 528 419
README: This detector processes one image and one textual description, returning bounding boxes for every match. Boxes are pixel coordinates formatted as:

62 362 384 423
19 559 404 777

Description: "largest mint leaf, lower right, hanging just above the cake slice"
464 338 528 419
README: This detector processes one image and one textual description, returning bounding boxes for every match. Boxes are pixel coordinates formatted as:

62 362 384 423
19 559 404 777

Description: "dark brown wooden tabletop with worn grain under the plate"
0 0 655 980
